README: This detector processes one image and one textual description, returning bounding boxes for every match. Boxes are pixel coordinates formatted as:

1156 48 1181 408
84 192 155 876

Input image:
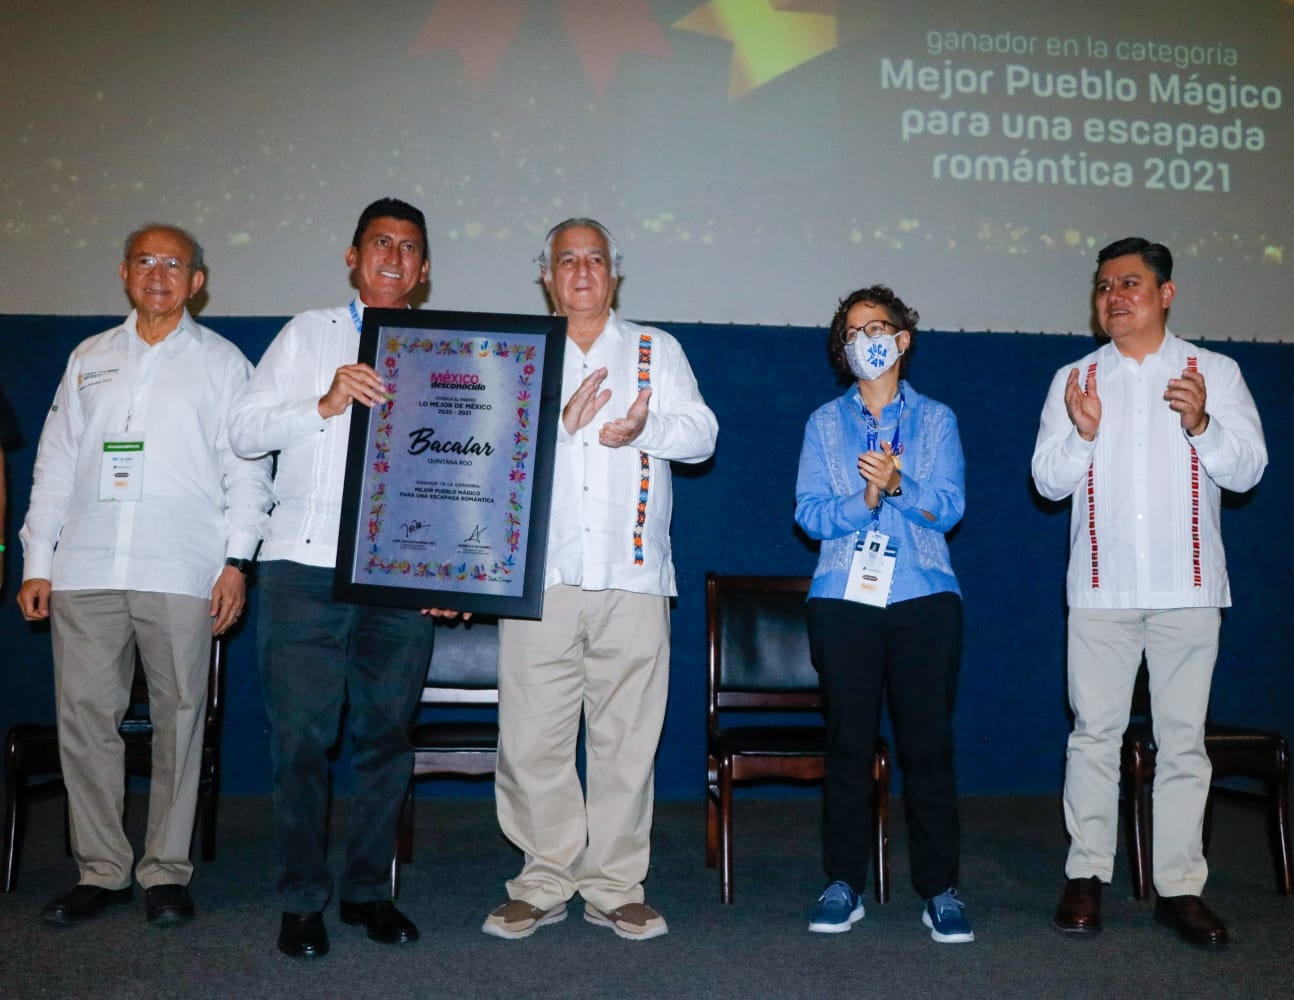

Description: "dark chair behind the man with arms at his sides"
0 636 225 893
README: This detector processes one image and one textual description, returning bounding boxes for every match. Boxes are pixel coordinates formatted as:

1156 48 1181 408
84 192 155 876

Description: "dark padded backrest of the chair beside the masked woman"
705 573 822 726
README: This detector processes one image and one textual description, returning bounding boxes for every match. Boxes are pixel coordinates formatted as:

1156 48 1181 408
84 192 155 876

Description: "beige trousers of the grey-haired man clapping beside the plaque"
494 586 669 911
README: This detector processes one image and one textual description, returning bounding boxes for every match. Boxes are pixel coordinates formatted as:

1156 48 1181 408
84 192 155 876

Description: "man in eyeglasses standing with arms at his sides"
18 225 269 925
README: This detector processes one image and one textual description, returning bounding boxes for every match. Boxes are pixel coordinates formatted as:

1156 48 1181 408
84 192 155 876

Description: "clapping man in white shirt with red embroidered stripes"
1033 237 1267 946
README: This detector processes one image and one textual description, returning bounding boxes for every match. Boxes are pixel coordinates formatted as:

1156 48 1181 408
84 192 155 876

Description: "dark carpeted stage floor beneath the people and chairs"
0 797 1294 1000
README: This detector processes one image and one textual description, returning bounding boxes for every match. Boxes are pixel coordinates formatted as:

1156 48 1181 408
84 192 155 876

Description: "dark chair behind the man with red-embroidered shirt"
1121 661 1294 899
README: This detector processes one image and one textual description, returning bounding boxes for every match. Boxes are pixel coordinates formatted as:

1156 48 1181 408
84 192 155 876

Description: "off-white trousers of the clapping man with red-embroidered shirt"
1065 608 1222 895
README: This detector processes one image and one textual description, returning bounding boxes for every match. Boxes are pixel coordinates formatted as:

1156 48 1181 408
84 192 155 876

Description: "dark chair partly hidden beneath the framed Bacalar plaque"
391 614 498 897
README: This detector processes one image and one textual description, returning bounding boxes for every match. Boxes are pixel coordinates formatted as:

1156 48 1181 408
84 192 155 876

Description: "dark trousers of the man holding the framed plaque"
258 560 435 913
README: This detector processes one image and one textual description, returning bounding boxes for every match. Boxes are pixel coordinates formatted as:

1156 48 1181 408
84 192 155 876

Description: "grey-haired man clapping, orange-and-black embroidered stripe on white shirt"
481 219 718 940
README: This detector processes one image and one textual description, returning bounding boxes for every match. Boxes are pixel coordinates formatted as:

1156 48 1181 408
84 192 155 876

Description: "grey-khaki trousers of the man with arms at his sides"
49 590 211 889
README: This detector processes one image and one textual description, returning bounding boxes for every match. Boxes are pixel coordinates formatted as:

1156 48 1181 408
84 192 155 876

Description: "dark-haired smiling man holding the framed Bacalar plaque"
230 198 452 957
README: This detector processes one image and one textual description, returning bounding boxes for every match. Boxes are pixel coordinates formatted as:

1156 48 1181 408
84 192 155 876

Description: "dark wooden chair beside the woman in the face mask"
705 573 889 903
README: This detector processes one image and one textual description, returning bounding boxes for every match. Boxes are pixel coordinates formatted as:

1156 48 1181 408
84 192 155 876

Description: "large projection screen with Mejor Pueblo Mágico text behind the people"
0 0 1294 340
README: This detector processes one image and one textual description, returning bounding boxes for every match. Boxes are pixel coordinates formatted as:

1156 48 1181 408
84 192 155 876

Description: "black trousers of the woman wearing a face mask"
809 594 961 899
